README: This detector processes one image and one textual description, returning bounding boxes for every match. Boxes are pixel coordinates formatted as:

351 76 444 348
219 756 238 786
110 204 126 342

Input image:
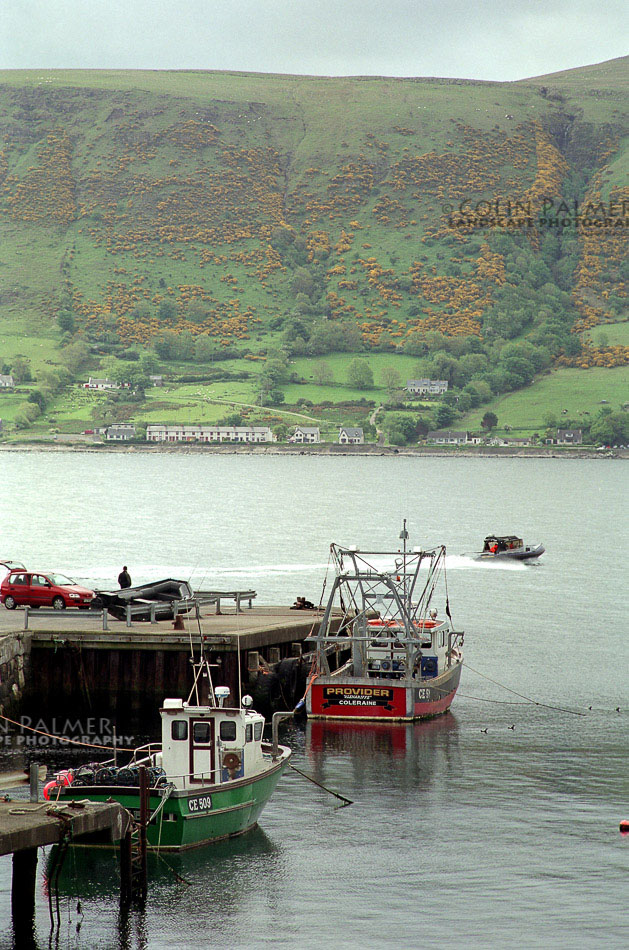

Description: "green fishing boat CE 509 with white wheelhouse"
44 661 291 851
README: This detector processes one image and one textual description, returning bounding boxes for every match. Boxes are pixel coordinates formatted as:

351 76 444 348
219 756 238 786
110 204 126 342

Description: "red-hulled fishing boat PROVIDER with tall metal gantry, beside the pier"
304 522 463 721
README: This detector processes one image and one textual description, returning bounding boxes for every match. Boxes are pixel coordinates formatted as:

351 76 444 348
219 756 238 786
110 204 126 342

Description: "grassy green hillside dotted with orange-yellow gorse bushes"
0 59 629 444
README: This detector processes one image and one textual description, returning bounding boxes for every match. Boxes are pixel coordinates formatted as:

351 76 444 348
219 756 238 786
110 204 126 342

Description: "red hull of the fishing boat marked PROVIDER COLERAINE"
306 662 462 722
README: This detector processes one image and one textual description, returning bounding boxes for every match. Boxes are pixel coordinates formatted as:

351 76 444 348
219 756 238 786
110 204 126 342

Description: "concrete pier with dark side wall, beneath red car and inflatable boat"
0 605 321 714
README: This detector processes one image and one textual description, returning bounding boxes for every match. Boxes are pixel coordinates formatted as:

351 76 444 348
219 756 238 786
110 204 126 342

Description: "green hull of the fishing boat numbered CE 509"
59 749 290 851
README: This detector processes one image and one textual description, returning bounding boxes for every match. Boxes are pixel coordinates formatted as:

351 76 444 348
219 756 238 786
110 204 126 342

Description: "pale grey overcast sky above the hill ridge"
0 0 629 81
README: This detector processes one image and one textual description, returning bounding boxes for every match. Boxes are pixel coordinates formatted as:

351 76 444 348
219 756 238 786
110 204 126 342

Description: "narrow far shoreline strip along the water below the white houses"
0 442 629 459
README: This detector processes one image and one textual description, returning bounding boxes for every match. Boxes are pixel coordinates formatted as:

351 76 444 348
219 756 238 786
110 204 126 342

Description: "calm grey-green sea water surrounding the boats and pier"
0 452 629 950
